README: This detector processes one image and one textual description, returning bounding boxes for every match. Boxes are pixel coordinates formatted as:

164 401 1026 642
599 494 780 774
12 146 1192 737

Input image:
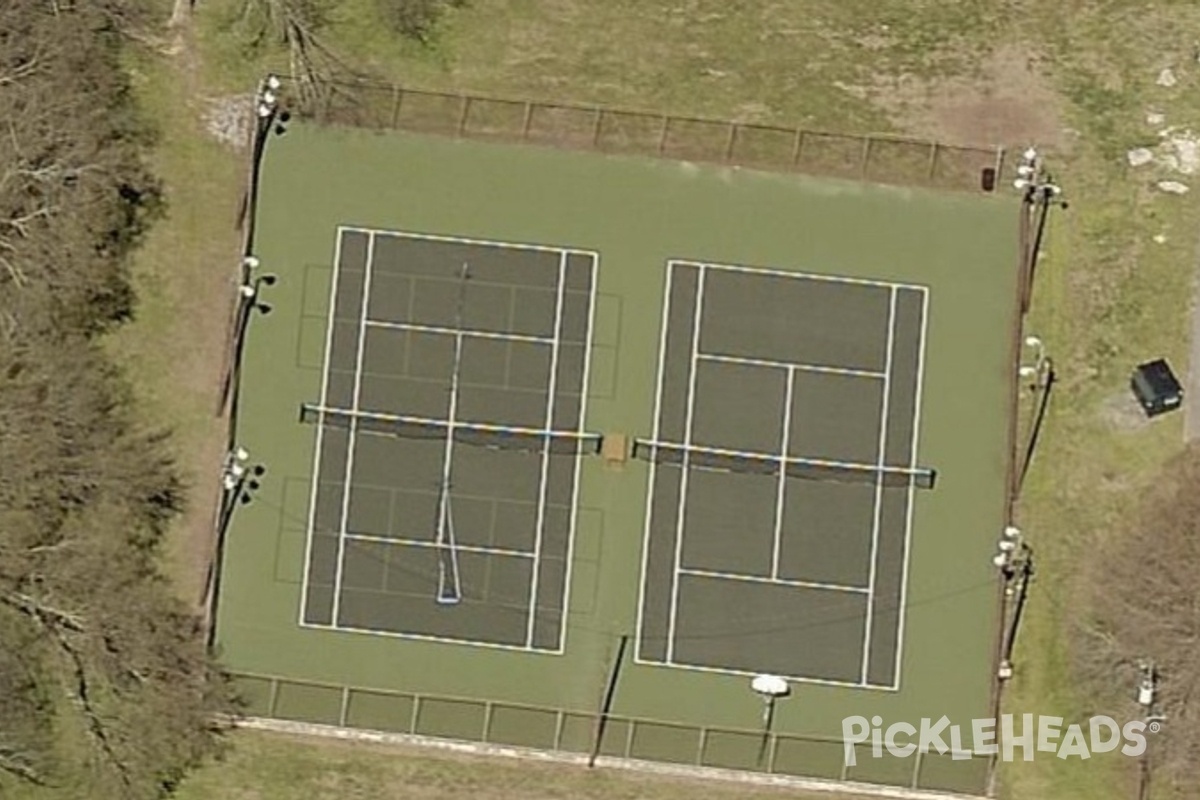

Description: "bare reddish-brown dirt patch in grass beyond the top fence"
865 46 1068 150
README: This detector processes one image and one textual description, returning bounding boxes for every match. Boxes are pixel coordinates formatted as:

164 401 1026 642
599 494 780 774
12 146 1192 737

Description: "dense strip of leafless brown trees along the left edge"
0 0 232 800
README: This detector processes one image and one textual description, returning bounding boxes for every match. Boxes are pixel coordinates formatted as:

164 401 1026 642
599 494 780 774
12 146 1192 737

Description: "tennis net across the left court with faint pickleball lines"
300 403 602 456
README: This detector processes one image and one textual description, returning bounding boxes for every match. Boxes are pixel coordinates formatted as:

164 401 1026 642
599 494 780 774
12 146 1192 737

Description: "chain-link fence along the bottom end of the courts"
234 674 989 794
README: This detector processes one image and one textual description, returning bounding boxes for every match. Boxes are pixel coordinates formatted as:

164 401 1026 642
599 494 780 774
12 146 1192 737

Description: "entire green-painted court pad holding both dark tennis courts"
217 122 1019 792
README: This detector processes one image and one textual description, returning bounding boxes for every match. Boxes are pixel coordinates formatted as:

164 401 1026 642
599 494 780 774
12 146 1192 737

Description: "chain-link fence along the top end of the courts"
283 82 1004 192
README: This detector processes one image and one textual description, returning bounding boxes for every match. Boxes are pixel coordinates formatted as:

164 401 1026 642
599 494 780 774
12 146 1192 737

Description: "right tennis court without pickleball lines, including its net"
634 261 935 688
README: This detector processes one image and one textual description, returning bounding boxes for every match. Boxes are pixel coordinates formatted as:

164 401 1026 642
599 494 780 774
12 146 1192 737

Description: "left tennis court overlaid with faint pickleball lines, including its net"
300 227 600 652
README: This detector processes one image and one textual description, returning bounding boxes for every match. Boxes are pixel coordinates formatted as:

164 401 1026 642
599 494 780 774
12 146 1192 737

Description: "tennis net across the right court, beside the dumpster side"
634 439 937 489
